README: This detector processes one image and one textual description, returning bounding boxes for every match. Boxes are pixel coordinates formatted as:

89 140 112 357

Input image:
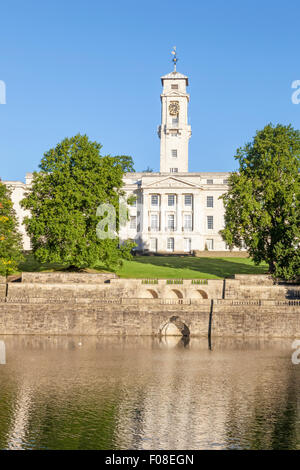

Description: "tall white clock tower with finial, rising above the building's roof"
158 47 192 173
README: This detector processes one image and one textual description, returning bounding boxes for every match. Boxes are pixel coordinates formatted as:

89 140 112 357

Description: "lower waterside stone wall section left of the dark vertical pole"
0 300 210 336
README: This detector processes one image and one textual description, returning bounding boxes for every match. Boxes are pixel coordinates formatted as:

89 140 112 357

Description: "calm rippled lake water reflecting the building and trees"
0 336 300 449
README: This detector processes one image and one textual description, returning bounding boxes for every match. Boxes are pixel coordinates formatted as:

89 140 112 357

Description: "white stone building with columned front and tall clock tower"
1 56 237 253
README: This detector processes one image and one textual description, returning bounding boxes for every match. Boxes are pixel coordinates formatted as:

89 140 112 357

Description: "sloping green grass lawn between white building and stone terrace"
20 255 267 279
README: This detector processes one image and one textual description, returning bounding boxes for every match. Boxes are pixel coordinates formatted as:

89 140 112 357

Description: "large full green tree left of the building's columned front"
21 134 134 268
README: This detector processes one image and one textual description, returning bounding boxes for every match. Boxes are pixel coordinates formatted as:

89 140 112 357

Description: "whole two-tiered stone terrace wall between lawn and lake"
0 273 300 338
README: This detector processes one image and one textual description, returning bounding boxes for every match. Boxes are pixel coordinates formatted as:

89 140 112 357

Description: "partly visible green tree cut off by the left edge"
0 181 23 276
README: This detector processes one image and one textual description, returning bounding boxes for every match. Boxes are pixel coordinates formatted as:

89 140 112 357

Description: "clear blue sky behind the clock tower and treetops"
0 0 300 180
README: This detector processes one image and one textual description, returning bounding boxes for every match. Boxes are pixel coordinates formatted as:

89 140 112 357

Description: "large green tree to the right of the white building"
221 124 300 279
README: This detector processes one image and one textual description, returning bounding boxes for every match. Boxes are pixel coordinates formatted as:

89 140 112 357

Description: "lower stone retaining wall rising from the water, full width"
0 299 300 338
